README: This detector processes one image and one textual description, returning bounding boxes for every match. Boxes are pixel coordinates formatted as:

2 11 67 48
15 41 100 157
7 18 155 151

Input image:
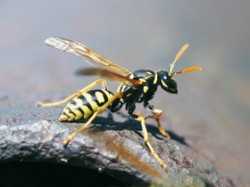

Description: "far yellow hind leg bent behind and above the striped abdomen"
36 79 107 107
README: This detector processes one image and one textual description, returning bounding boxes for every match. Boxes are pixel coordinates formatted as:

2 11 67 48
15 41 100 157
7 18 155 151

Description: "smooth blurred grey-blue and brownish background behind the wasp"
0 0 250 186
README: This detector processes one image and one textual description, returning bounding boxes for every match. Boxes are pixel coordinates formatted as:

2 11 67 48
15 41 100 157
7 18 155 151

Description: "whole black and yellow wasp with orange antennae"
37 37 201 170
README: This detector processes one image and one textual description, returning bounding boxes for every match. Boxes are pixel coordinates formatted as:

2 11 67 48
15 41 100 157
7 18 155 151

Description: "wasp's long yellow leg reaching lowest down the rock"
132 114 168 170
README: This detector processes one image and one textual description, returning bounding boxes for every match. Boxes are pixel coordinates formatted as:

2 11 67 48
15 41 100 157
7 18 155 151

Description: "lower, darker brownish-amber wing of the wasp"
76 68 143 86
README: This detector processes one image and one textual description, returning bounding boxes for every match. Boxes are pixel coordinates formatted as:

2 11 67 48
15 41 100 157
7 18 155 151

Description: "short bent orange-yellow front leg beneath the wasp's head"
144 102 170 137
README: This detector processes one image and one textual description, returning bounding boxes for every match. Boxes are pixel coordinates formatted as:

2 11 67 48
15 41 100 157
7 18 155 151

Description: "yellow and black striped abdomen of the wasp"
58 89 113 121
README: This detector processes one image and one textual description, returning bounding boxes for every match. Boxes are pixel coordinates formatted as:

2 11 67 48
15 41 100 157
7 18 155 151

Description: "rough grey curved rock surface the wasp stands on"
0 99 234 187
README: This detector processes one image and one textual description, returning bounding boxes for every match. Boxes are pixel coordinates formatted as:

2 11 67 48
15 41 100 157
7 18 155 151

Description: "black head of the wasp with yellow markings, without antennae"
157 70 178 94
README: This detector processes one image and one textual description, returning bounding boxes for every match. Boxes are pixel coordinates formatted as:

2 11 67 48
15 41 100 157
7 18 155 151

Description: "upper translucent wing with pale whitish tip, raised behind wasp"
45 37 130 75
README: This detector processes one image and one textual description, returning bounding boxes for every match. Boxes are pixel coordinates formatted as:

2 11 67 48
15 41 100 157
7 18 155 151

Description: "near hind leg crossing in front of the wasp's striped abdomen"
63 92 122 146
